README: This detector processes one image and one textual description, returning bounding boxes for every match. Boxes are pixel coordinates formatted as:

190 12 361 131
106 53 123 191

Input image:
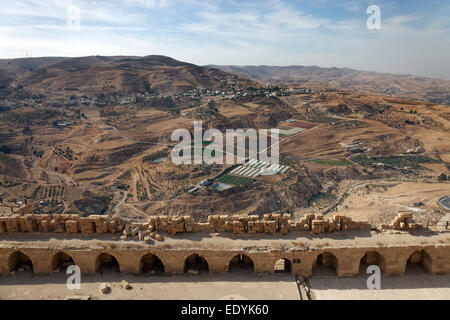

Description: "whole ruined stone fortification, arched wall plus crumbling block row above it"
0 209 442 277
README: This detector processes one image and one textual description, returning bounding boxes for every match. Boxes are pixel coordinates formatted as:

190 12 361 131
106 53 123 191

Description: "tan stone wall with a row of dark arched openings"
0 242 450 277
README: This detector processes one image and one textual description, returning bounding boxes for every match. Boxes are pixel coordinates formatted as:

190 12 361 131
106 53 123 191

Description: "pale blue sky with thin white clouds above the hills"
0 0 450 80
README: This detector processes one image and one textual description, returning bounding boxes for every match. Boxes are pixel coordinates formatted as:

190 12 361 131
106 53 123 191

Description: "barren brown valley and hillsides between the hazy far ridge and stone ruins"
0 56 450 228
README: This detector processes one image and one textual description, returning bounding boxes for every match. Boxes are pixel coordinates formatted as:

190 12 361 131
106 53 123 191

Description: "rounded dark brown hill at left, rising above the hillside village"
0 55 253 95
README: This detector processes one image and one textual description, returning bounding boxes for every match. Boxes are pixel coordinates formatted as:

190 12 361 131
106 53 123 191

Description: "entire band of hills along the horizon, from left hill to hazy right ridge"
0 55 450 105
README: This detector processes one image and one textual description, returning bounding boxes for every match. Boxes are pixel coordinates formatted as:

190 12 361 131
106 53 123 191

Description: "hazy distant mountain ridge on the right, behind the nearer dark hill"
211 65 450 105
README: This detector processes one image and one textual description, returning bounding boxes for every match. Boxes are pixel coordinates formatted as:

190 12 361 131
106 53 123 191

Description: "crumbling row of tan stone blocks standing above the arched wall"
0 213 390 240
